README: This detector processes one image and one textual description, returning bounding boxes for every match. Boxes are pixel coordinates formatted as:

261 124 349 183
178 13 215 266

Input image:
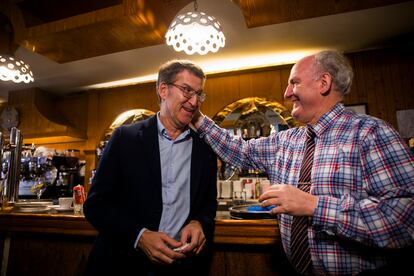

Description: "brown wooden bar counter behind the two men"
0 212 294 276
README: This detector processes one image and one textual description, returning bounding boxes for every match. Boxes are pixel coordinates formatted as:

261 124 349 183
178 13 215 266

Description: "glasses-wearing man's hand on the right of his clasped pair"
181 220 206 255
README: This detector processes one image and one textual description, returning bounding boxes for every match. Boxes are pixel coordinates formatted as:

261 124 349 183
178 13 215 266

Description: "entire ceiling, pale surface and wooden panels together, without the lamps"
0 0 414 101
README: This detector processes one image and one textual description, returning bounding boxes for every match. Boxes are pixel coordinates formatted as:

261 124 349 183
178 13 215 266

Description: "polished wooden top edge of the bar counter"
0 212 280 245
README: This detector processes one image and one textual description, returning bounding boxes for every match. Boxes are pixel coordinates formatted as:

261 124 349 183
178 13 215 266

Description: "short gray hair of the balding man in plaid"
314 50 354 97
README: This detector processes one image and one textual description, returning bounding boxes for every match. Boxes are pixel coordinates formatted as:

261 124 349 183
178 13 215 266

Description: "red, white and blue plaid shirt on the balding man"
199 104 414 275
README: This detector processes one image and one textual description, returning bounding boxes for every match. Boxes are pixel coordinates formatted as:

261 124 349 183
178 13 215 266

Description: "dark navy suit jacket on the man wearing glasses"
84 116 217 275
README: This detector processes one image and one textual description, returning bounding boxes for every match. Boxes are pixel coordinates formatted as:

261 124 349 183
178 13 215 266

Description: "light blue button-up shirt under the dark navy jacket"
157 114 193 240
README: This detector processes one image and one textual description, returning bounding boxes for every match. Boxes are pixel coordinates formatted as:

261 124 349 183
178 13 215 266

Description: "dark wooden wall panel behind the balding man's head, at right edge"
345 48 414 130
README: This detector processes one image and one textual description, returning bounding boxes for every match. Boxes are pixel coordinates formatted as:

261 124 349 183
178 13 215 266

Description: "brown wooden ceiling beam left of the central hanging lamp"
14 0 192 63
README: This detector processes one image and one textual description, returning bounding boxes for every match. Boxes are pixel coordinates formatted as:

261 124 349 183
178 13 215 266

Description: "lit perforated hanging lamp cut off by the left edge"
0 54 34 83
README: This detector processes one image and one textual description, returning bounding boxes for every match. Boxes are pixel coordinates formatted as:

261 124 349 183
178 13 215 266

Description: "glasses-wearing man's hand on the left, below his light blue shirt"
138 230 185 264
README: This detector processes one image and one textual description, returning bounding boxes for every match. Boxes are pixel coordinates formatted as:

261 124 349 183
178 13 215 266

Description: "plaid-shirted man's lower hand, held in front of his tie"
259 184 318 217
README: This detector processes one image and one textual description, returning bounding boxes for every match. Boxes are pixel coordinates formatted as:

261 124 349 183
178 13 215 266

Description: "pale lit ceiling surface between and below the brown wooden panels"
0 0 414 101
